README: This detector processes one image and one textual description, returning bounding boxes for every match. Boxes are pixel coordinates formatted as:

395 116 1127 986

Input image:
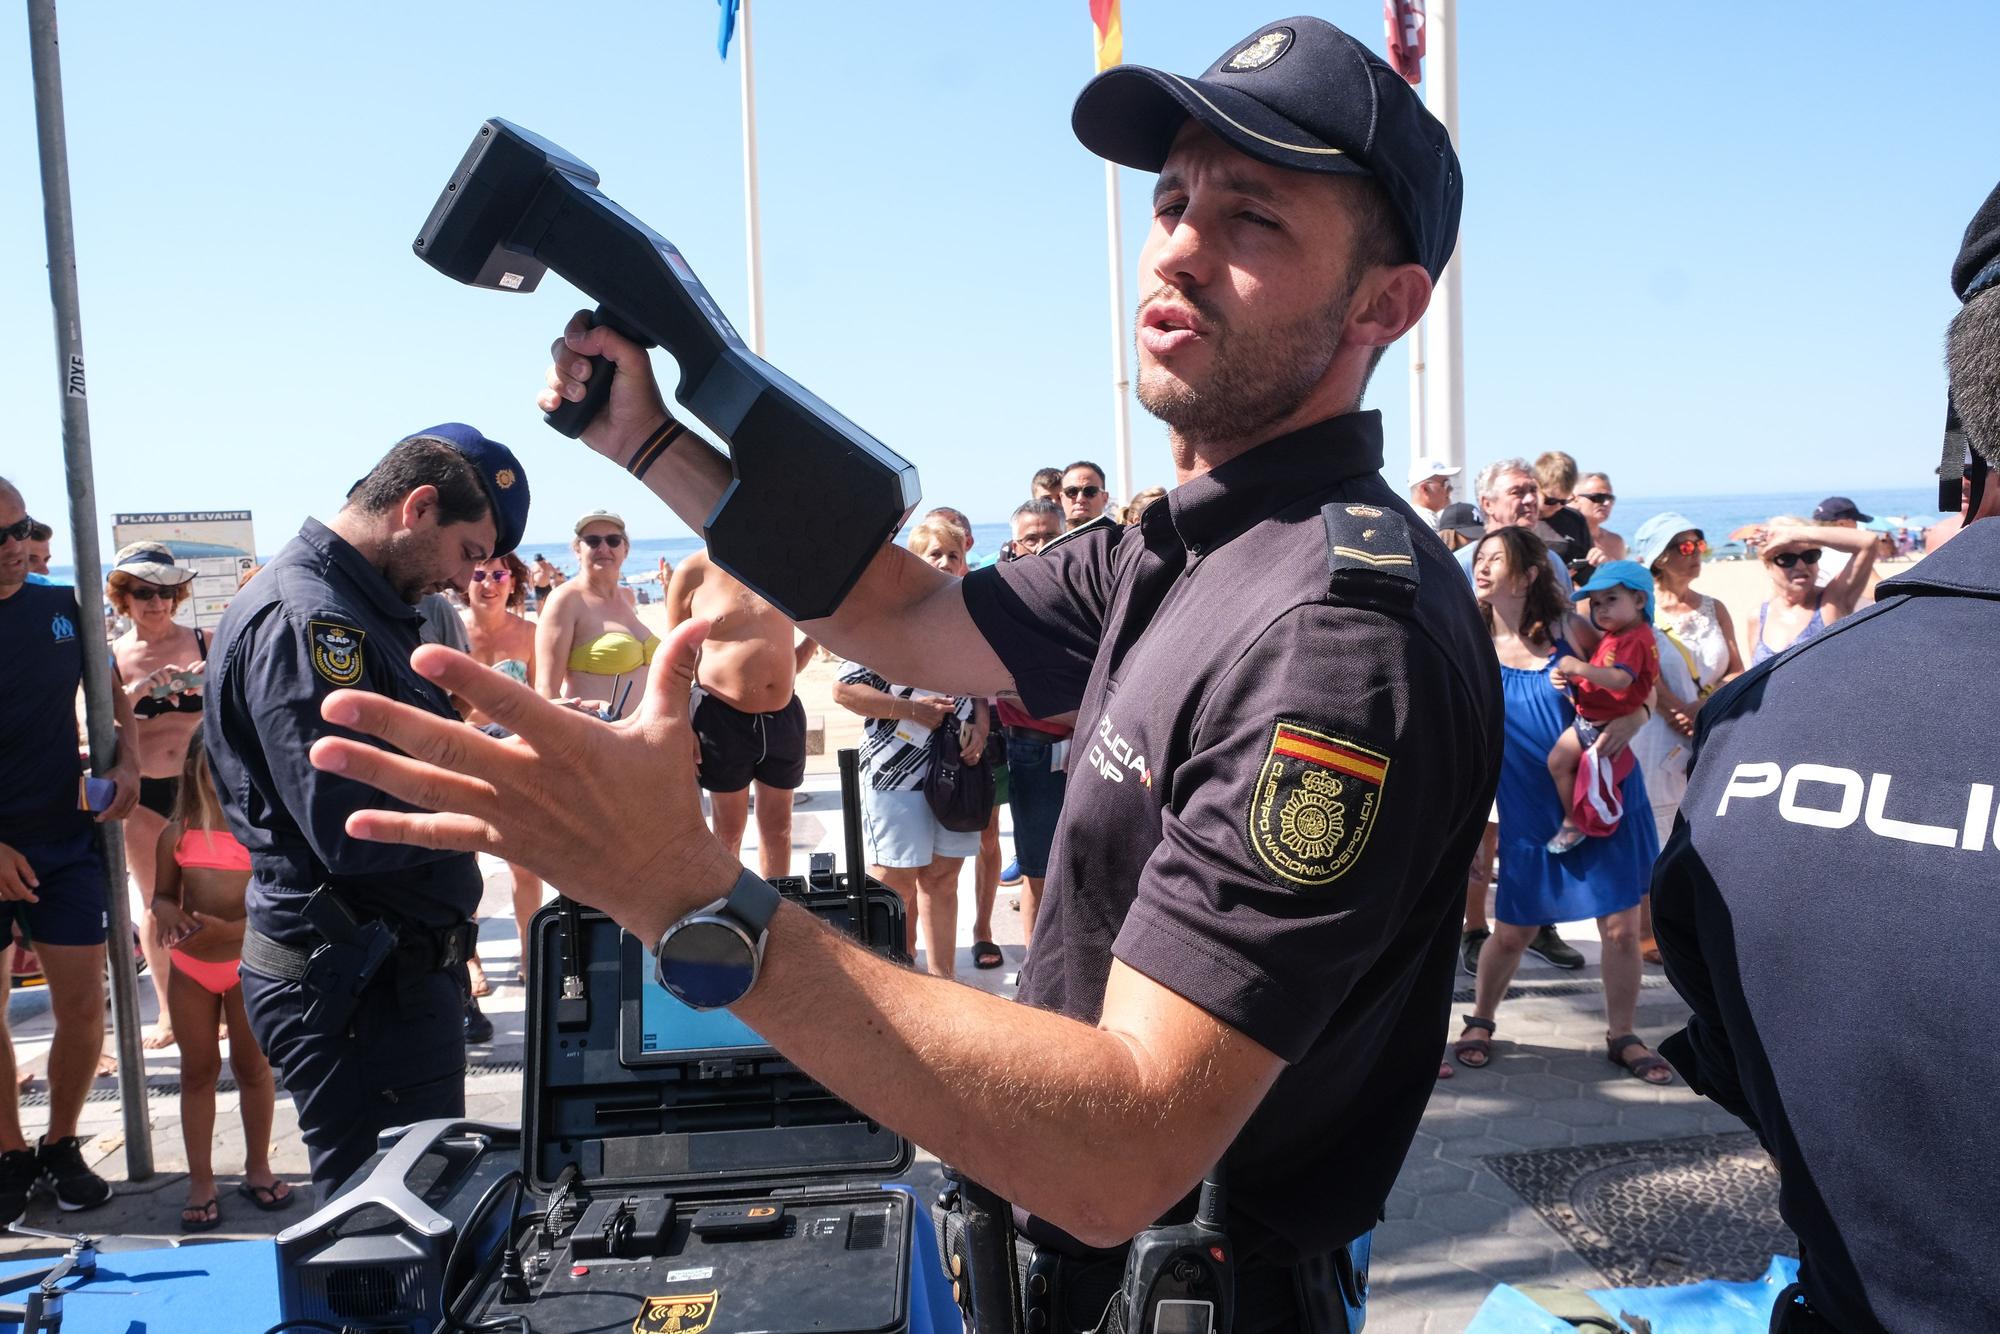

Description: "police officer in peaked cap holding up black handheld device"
314 18 1500 1332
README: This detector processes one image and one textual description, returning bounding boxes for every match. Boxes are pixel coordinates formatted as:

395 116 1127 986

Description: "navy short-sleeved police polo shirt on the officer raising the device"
964 412 1500 1264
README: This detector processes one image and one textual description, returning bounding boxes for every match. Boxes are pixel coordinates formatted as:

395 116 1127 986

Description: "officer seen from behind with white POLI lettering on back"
1652 180 2000 1334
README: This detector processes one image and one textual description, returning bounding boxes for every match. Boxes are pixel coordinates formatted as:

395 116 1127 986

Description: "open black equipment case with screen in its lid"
458 752 942 1334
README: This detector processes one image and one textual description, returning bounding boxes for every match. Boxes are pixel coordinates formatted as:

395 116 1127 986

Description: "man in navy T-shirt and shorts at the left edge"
0 478 152 1224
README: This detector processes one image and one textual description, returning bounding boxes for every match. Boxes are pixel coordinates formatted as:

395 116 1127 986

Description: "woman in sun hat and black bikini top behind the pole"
104 542 208 1050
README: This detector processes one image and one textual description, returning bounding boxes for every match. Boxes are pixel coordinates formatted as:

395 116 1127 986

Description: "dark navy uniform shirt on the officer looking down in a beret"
202 520 480 944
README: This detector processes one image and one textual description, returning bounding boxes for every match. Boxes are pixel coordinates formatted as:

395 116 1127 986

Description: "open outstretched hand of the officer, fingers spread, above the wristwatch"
310 620 742 938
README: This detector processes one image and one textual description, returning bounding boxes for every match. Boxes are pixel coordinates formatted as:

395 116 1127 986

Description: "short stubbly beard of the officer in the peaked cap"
1138 274 1360 444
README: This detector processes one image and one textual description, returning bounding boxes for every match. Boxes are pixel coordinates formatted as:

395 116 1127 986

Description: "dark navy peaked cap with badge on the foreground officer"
1070 16 1464 278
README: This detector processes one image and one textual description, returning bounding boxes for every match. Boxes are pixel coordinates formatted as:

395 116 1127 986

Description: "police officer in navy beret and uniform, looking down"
202 422 528 1198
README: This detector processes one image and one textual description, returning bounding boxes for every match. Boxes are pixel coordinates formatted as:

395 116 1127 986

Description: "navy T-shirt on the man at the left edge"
0 584 91 844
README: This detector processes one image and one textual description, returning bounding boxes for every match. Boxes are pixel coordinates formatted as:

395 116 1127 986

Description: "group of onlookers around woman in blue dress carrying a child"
1408 450 1900 1082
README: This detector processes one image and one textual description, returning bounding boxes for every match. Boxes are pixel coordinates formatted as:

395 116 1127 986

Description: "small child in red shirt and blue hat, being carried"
1548 560 1660 852
